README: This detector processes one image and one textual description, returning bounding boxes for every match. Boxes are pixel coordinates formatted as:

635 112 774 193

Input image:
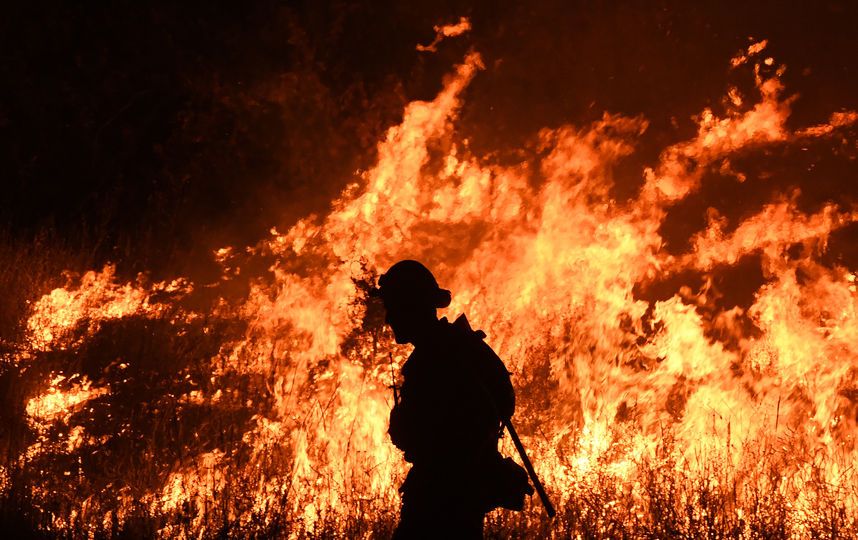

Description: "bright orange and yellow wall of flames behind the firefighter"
6 35 858 537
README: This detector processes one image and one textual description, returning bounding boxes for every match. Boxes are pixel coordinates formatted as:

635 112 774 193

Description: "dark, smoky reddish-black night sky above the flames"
0 1 858 274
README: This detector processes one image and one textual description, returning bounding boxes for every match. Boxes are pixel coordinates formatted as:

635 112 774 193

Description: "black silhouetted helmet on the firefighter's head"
373 260 450 308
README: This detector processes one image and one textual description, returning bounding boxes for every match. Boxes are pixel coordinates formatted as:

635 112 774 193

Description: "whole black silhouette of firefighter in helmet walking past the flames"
373 260 533 539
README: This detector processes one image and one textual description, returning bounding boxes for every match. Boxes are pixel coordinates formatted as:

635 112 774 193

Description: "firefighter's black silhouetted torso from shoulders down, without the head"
389 316 515 538
